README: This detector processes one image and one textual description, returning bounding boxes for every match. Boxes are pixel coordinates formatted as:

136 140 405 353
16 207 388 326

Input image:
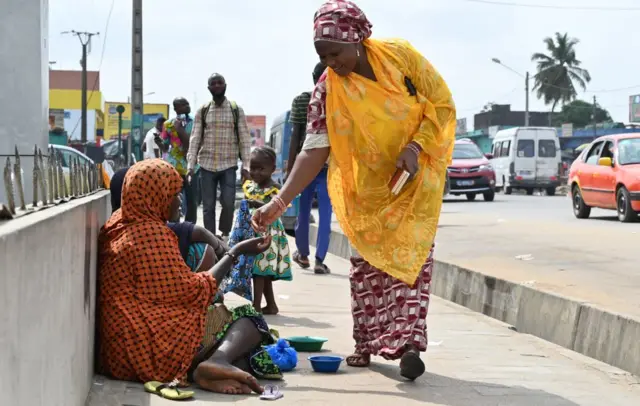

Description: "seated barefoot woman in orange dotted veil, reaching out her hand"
98 159 282 394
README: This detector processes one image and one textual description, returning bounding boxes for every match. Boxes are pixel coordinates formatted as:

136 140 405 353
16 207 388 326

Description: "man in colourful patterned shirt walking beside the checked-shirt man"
161 97 198 224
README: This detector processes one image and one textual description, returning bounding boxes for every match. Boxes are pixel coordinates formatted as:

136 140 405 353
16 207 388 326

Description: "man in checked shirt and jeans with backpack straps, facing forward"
187 73 251 240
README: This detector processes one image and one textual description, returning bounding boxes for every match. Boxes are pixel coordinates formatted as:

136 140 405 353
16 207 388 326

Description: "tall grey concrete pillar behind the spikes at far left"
0 0 49 203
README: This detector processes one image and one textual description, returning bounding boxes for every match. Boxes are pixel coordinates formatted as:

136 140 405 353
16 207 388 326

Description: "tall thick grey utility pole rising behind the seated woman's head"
127 0 144 164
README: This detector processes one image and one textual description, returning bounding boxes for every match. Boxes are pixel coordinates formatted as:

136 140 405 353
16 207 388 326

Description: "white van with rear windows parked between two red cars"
491 127 562 196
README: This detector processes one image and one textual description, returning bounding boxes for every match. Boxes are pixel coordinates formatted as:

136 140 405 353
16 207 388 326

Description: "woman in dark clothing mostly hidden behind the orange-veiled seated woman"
110 168 229 274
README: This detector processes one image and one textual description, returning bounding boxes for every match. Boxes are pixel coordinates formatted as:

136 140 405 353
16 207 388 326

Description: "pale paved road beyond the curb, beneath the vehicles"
436 195 640 317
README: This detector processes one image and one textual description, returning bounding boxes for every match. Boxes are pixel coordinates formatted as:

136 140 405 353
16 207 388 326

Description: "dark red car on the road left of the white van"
445 140 496 202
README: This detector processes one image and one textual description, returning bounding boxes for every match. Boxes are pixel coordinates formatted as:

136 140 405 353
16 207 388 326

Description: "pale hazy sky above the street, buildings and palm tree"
49 0 640 128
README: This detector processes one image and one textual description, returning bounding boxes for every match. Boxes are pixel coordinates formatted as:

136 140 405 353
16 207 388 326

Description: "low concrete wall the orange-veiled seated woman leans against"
0 192 110 406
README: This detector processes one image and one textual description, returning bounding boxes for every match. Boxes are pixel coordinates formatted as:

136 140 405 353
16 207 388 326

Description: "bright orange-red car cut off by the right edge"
569 133 640 223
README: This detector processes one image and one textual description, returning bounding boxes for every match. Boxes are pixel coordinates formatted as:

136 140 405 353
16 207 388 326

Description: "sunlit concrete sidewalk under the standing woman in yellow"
87 246 640 406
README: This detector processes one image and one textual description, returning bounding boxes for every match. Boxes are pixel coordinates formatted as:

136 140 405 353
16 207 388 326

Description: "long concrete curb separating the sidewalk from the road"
309 225 640 375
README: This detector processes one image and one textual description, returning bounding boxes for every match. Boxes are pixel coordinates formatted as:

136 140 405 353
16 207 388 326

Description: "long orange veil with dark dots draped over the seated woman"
98 159 216 382
